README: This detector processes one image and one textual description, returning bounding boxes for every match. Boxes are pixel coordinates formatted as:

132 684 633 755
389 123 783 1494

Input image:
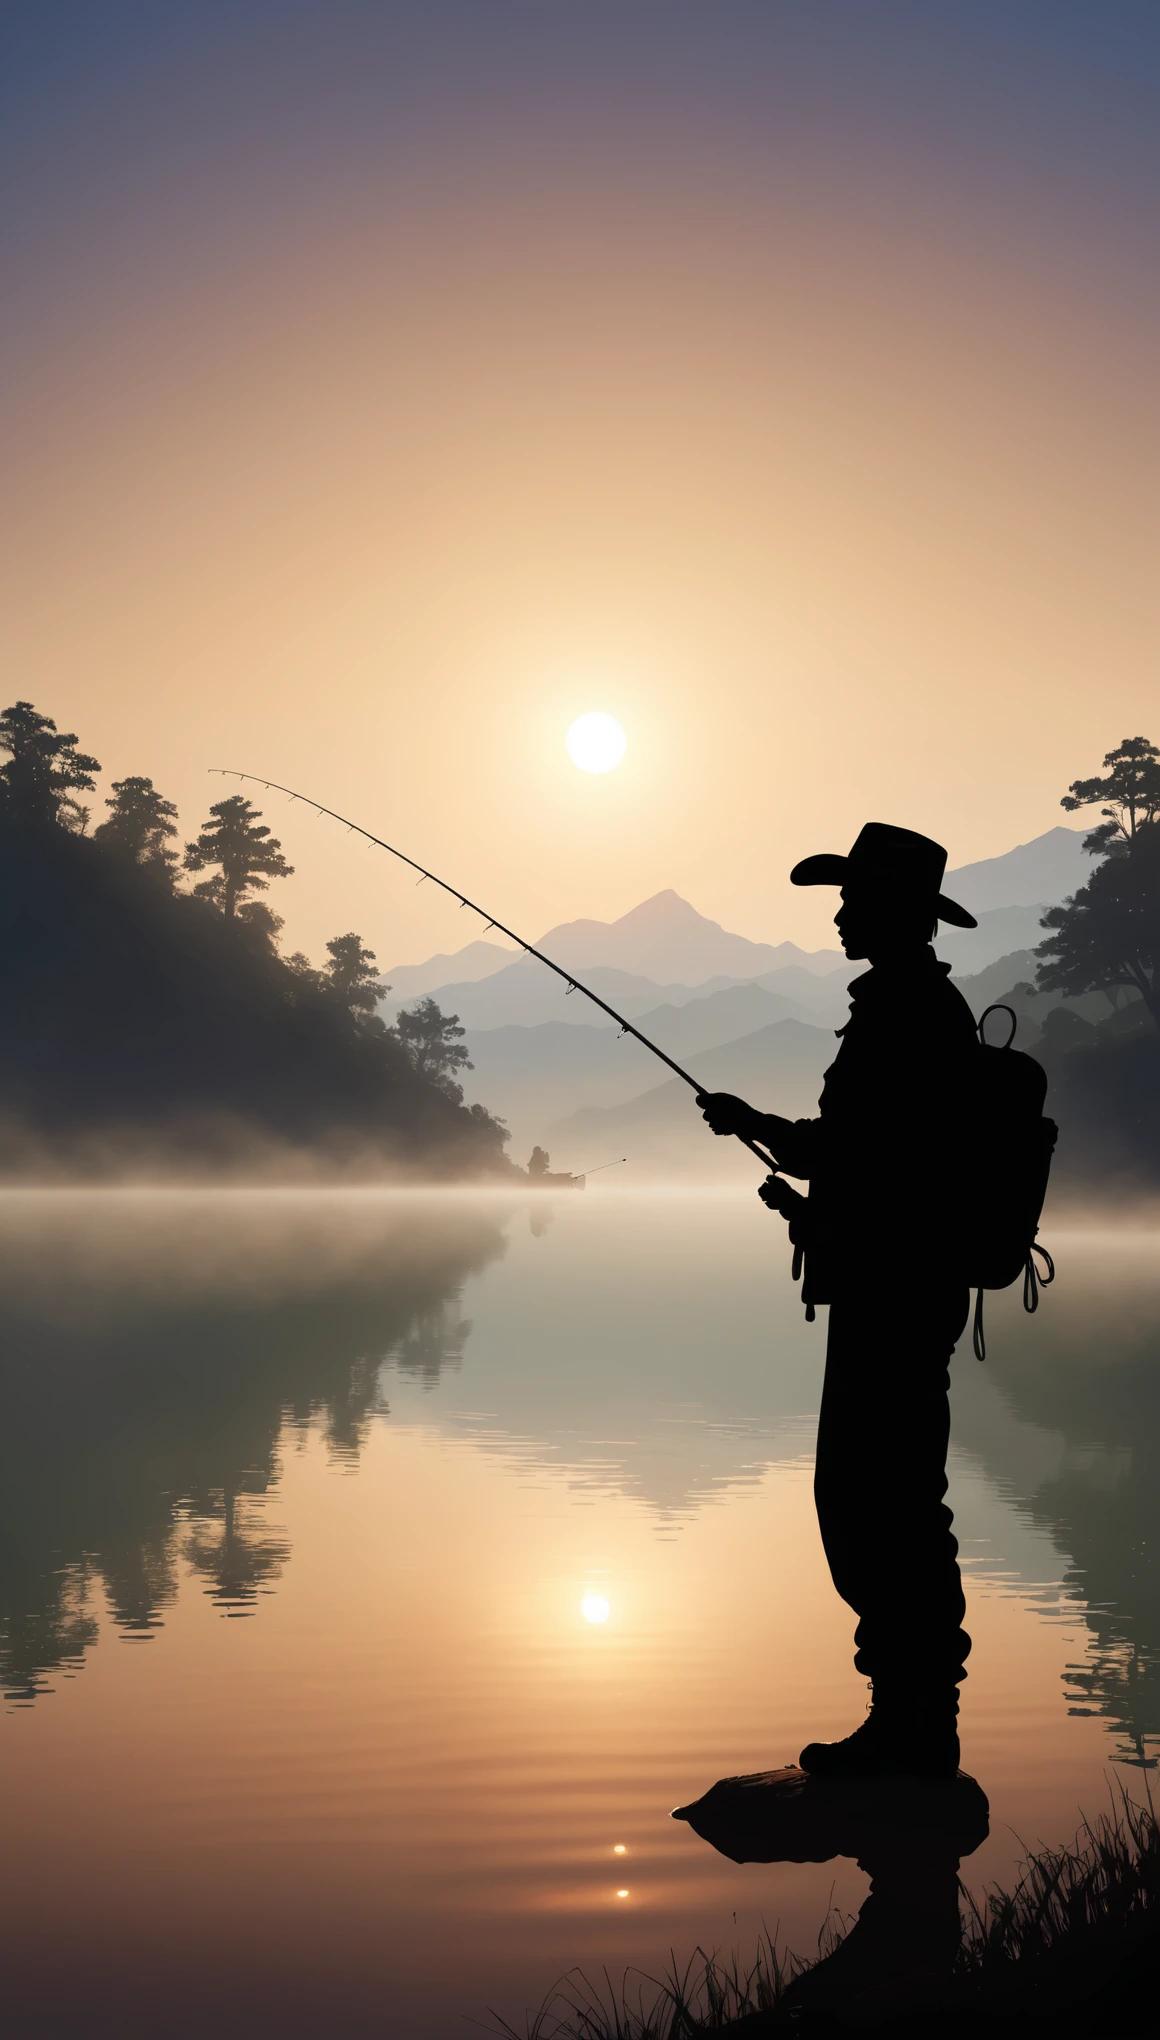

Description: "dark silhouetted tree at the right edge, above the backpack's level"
1036 736 1160 1026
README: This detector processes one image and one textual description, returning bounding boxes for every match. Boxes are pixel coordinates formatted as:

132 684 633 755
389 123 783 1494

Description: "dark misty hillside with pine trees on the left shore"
0 704 510 1177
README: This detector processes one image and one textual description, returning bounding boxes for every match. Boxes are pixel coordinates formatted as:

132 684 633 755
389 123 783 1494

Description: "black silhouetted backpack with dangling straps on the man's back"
962 1006 1060 1361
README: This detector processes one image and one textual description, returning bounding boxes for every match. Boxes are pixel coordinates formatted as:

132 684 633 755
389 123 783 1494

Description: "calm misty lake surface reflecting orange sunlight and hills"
0 1185 1160 2040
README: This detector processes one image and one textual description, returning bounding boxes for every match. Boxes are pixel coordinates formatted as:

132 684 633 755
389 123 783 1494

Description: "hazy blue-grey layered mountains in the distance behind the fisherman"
381 828 1091 1177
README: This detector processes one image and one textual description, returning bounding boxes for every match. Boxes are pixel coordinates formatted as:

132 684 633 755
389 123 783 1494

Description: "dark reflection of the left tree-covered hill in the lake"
0 1195 504 1701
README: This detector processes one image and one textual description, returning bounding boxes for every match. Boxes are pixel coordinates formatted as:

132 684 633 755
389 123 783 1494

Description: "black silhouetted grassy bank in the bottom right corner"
491 1793 1160 2040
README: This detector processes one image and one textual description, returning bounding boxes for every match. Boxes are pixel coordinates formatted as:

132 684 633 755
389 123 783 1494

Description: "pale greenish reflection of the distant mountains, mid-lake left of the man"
379 1195 826 1536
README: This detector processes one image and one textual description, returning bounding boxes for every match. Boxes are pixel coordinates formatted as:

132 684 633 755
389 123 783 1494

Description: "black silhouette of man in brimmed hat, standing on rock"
699 822 979 1777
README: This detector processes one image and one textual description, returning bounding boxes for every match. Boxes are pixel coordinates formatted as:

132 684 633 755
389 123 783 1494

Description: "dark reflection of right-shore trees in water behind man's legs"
956 1234 1160 1763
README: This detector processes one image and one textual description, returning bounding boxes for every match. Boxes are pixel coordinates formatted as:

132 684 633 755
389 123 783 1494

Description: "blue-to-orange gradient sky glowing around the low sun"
0 0 1160 967
